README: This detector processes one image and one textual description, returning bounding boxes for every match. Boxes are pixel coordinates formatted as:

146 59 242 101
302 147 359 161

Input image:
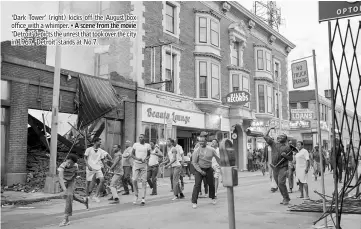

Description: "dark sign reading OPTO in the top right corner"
318 1 361 22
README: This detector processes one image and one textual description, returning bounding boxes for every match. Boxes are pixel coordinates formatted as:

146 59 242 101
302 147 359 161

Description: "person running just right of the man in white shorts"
109 145 124 204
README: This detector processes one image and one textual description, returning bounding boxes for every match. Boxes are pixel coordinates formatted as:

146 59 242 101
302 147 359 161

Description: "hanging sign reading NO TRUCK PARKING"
291 60 310 89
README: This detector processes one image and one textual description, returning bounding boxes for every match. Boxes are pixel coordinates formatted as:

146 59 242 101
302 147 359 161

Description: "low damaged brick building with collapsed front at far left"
1 41 136 185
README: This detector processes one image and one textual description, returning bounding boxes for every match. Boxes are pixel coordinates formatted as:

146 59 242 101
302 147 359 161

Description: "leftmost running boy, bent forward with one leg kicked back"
58 154 89 227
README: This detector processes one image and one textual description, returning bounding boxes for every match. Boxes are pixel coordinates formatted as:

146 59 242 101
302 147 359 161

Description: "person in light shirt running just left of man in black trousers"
163 138 184 200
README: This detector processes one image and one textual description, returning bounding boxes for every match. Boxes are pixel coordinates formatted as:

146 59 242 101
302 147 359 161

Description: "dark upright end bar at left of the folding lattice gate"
328 21 340 229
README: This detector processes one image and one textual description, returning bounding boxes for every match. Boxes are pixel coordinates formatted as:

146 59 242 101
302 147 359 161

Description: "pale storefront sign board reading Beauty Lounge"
142 104 204 128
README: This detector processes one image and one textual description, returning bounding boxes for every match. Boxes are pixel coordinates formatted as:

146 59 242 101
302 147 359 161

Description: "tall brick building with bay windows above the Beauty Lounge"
125 2 295 169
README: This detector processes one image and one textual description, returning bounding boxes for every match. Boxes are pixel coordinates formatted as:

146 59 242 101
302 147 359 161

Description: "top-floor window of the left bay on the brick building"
195 10 220 50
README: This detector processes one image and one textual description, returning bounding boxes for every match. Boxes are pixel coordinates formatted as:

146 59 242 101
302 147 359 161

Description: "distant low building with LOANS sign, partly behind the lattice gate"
289 90 361 150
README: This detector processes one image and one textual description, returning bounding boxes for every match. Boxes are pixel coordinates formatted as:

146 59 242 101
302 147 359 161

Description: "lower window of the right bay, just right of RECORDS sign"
257 84 273 114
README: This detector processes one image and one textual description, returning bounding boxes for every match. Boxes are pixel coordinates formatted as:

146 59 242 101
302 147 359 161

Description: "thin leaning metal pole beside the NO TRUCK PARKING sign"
312 49 327 227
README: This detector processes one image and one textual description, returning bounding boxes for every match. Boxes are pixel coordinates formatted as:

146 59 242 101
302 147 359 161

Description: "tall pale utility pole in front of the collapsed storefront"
44 1 63 193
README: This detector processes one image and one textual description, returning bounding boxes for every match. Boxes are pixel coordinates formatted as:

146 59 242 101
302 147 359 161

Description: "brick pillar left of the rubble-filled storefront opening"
6 82 28 173
